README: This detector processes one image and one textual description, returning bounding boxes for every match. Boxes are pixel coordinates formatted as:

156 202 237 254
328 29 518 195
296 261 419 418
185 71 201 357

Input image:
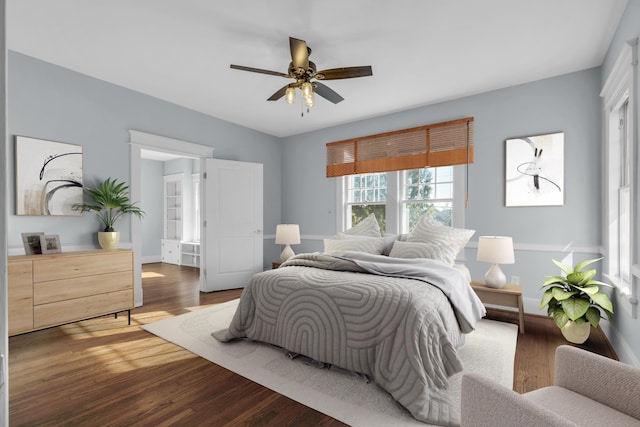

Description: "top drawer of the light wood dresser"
33 251 133 282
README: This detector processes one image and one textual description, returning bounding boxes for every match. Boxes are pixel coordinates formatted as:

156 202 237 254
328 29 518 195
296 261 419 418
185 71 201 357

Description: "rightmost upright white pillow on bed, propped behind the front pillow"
407 216 476 265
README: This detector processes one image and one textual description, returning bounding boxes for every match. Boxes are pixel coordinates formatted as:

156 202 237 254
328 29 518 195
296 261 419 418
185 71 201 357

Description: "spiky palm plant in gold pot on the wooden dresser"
72 178 144 249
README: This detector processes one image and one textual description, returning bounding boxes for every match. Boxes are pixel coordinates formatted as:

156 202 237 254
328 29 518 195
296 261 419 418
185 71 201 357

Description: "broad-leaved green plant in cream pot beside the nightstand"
540 258 613 344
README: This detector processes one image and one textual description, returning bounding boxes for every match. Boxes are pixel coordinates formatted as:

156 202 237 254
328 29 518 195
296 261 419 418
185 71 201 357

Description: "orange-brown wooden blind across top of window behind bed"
327 117 473 177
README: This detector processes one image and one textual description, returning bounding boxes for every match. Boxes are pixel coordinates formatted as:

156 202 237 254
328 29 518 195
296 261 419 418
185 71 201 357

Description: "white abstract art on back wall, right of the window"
505 132 564 206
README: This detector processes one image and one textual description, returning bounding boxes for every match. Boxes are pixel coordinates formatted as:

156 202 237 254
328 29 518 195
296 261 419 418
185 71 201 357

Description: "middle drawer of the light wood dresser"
33 271 133 305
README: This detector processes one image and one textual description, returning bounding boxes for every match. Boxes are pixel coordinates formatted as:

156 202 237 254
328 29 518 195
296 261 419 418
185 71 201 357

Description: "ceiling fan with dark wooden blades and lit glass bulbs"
231 37 373 107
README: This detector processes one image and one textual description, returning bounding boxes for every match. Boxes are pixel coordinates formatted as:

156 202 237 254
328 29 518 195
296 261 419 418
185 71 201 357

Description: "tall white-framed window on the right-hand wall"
600 39 638 317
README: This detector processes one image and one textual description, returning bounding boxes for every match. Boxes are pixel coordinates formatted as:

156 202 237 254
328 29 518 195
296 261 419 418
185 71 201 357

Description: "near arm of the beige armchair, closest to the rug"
460 373 576 427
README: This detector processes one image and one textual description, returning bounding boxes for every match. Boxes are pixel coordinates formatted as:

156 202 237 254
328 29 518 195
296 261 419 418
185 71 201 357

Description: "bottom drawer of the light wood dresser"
33 289 133 328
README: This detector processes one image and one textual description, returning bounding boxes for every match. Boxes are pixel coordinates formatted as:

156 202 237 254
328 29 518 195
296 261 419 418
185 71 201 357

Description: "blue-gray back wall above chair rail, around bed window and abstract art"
282 69 601 252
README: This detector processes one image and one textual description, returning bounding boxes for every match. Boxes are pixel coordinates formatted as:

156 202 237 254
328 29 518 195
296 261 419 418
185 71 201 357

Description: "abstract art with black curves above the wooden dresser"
15 136 83 215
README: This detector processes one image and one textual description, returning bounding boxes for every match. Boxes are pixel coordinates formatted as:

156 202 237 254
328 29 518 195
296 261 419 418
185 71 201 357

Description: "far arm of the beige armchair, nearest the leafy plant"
554 345 640 419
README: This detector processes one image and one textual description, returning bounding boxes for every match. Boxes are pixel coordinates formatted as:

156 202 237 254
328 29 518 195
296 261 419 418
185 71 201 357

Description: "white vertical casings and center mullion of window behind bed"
336 165 467 234
